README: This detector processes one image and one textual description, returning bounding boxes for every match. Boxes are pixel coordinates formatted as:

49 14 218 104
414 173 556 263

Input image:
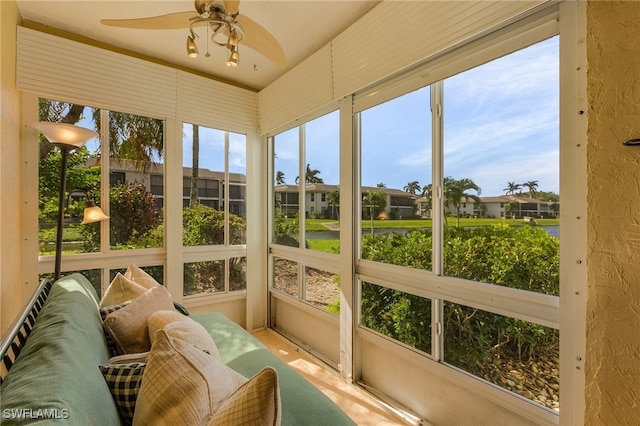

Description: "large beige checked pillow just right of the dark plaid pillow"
133 330 247 426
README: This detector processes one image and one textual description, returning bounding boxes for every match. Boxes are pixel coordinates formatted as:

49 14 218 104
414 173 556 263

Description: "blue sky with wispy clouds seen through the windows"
80 37 559 196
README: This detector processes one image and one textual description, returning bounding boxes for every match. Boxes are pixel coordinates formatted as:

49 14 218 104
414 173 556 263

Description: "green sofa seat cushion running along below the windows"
191 313 355 426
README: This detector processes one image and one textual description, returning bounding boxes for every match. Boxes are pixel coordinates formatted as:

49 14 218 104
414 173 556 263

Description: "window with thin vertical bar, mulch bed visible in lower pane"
270 111 340 314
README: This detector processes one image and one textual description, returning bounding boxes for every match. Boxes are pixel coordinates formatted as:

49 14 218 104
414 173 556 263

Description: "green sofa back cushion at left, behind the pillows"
0 274 120 426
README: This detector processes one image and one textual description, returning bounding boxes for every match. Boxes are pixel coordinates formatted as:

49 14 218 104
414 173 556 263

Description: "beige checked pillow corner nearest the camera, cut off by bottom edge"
209 367 282 426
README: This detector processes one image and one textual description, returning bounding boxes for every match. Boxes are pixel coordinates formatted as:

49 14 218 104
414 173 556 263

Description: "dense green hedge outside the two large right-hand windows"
361 225 559 364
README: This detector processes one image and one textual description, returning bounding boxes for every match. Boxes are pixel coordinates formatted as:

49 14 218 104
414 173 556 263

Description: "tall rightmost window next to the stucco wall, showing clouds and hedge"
444 37 559 409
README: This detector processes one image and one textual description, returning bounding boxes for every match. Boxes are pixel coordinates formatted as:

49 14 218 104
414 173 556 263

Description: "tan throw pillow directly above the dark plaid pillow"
102 286 173 355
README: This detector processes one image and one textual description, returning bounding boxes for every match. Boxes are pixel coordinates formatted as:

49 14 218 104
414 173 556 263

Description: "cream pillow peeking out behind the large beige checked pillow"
147 310 220 359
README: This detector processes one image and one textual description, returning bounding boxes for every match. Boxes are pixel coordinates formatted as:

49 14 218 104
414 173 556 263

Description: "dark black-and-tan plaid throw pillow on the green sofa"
100 362 147 425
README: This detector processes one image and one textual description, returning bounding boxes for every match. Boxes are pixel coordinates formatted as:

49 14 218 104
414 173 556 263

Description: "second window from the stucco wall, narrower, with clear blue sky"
360 87 432 354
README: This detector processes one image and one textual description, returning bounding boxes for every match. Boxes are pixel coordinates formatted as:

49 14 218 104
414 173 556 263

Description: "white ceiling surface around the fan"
17 0 379 90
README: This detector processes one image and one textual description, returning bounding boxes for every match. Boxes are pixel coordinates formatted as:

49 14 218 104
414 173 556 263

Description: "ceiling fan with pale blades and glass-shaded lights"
100 0 287 69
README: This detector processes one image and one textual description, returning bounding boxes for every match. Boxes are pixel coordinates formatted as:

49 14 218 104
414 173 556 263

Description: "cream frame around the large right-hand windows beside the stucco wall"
353 3 586 424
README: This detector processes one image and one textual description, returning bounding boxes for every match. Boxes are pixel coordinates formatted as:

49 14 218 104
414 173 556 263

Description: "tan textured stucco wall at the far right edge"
585 1 640 425
